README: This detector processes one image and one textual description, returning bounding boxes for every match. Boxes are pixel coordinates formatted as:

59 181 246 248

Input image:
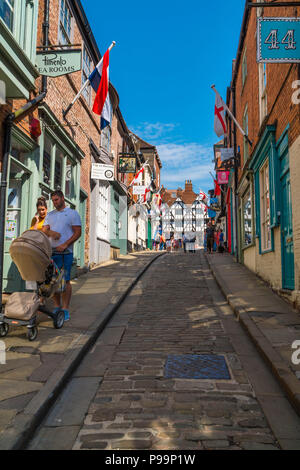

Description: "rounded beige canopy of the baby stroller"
9 230 52 282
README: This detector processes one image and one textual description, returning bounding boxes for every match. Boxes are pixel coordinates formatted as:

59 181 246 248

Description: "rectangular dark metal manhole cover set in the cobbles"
164 354 230 380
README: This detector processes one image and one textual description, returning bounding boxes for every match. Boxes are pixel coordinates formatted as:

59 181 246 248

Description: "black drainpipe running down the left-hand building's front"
0 0 50 312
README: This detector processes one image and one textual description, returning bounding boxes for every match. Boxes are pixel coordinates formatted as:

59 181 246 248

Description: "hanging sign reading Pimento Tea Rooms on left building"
36 49 81 77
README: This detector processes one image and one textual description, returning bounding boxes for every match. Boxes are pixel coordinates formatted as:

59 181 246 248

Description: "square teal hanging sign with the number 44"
257 17 300 63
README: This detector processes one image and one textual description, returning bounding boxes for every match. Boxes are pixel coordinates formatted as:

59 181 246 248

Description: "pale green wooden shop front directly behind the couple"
3 105 85 293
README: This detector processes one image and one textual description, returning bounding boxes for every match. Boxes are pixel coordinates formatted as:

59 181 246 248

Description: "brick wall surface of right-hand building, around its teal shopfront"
230 2 300 298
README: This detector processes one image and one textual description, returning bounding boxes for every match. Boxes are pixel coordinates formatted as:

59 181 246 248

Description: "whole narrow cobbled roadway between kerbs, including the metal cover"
30 252 299 450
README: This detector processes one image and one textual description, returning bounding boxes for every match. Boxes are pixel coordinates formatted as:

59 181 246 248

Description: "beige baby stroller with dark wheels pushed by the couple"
0 230 65 341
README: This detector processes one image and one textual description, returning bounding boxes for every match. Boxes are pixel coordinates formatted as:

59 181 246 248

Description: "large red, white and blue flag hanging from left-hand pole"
89 49 112 129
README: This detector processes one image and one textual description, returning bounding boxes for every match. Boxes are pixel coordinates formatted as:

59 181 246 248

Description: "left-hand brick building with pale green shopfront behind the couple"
0 0 140 292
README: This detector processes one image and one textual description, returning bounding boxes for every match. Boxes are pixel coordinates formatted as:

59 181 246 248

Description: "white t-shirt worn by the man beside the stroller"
44 207 81 252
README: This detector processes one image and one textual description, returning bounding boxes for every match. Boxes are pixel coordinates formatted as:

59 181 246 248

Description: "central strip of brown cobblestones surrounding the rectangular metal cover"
61 254 288 450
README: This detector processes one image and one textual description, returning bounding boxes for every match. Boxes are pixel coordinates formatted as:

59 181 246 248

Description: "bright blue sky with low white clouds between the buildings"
82 0 245 192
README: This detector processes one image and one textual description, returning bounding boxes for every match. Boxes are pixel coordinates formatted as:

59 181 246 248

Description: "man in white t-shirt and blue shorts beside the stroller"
43 190 81 321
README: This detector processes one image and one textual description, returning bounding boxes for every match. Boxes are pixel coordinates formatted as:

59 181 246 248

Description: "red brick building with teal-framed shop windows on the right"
227 2 300 301
